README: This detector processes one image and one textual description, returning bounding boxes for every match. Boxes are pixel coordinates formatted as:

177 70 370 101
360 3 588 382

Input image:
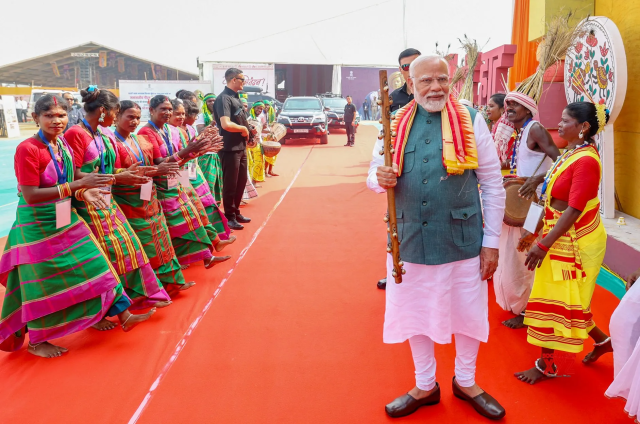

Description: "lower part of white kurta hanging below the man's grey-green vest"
383 255 489 344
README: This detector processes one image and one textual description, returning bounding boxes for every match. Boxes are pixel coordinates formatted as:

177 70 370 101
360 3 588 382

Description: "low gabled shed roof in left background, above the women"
0 41 198 87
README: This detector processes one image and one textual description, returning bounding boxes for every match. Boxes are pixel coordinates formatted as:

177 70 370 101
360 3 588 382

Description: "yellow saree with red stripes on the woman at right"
524 146 607 353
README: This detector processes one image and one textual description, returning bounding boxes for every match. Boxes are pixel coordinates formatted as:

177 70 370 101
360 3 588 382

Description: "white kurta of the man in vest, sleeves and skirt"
367 113 505 343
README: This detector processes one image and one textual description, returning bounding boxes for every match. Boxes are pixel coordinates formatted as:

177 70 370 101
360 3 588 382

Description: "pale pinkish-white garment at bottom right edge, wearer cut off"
605 281 640 417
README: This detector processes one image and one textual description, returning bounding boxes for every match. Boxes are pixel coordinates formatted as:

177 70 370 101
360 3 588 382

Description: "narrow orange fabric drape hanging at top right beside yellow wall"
509 0 538 90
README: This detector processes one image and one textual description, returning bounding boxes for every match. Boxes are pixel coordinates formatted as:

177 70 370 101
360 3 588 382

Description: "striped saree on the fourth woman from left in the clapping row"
138 125 219 265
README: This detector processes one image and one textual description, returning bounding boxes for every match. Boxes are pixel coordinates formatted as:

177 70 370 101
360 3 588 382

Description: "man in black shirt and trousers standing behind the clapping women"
213 68 251 230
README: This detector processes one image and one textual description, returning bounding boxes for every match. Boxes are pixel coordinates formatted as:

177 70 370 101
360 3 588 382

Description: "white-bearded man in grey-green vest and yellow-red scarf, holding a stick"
367 56 505 419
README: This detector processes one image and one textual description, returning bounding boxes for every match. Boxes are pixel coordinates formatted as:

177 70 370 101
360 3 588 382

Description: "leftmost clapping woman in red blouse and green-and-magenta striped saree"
0 94 155 358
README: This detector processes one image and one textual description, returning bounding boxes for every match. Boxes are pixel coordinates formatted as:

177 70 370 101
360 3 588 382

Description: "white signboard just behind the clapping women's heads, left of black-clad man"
120 80 211 121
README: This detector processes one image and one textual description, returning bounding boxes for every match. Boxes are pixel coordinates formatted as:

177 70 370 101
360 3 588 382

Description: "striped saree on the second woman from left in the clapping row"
74 129 170 310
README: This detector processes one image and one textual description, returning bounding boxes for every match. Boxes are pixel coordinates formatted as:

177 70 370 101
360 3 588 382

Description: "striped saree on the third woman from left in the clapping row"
113 134 185 289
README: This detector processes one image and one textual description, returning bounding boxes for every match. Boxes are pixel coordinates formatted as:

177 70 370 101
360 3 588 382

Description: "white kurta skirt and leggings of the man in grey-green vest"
383 255 489 390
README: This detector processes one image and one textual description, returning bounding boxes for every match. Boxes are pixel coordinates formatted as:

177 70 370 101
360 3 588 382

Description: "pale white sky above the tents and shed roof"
0 0 513 73
